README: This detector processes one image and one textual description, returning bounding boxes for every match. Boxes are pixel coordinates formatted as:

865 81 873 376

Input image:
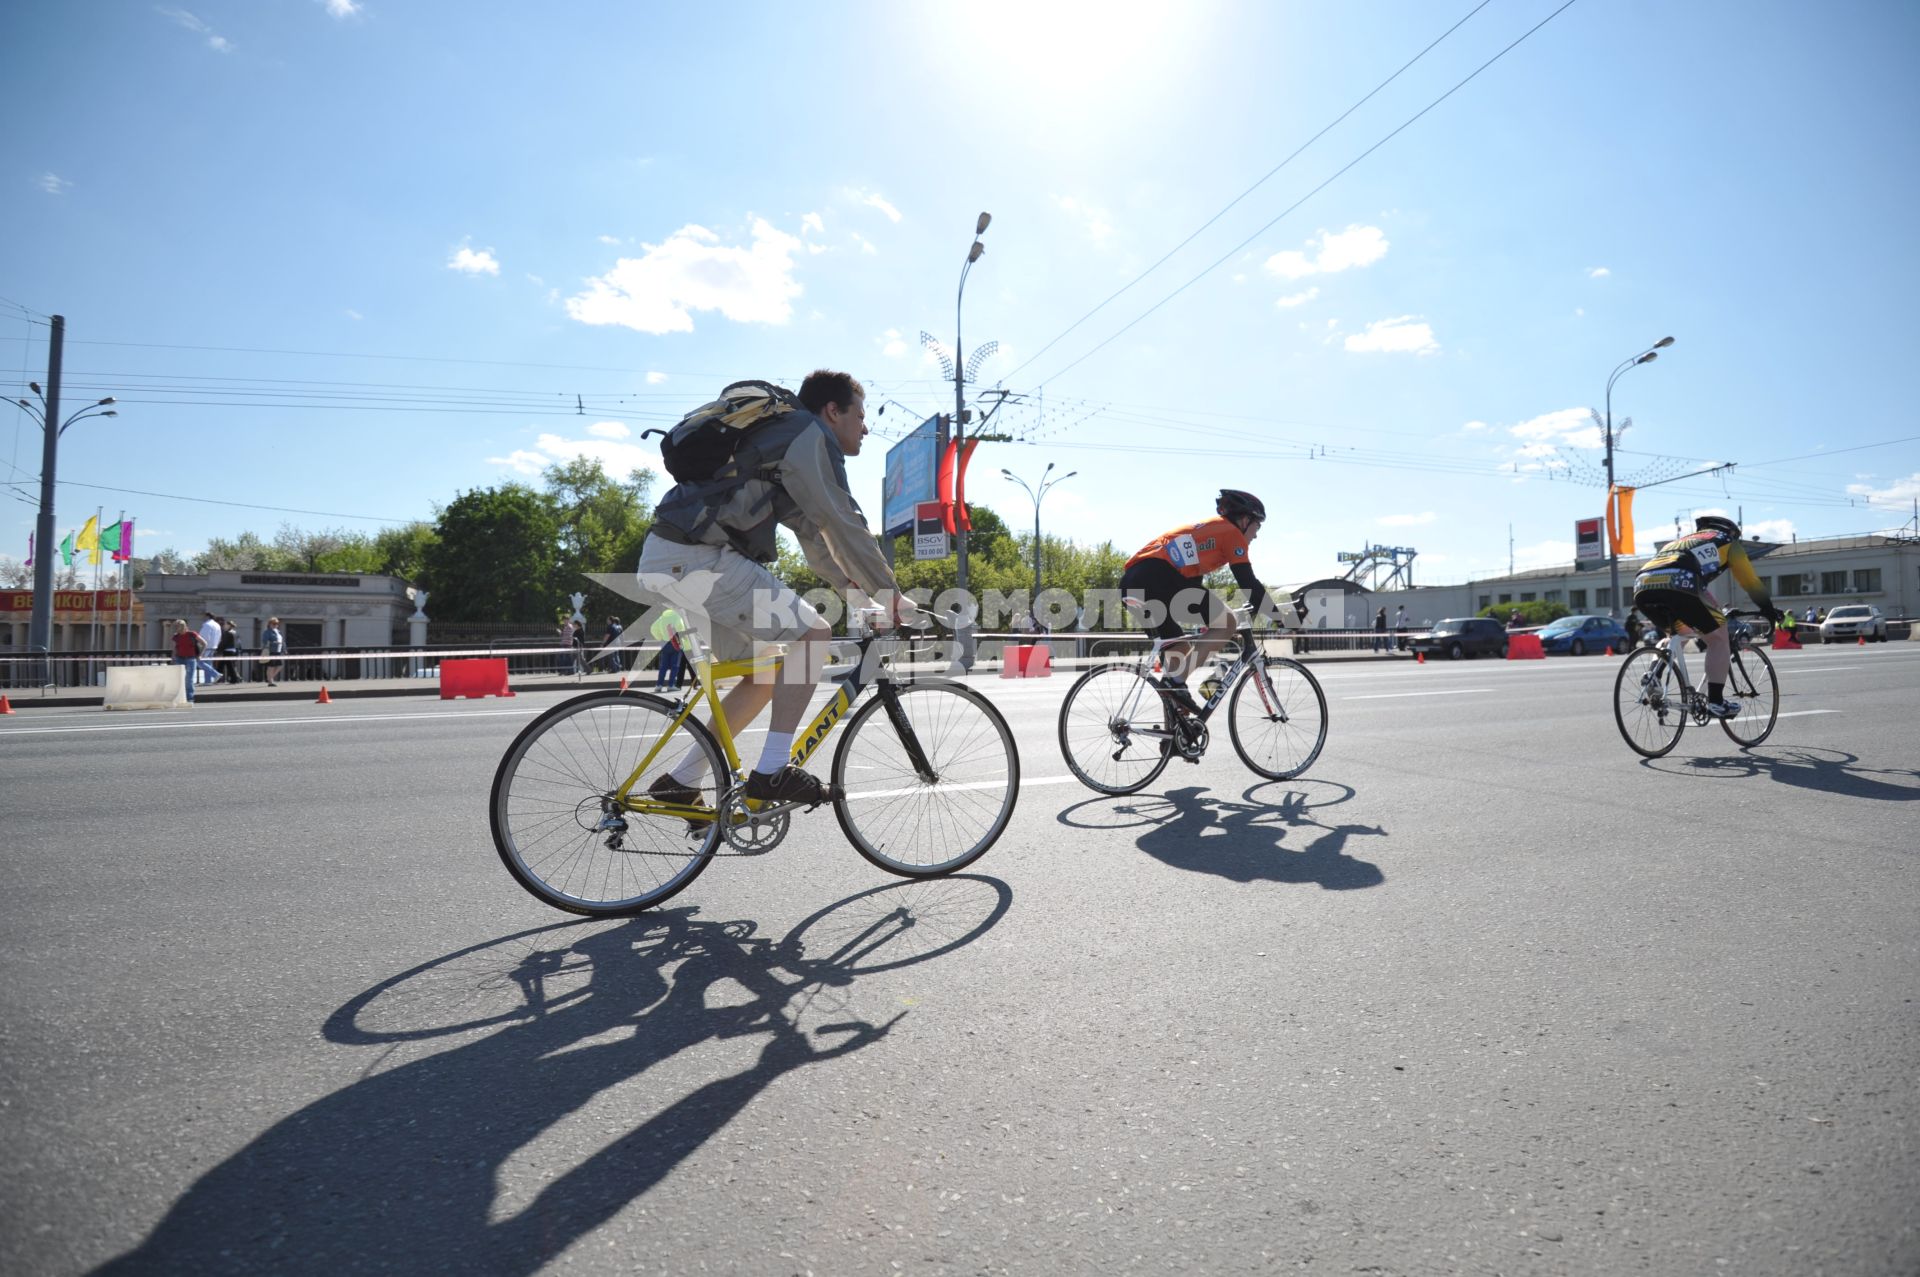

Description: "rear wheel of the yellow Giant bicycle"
490 691 728 918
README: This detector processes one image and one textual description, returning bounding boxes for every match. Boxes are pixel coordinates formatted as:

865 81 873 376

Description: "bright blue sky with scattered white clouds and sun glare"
0 0 1920 590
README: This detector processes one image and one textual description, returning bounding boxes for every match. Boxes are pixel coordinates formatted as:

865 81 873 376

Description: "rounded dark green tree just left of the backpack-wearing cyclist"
420 484 568 624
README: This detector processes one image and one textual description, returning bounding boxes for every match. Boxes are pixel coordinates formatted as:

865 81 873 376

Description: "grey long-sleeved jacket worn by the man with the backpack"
653 413 899 595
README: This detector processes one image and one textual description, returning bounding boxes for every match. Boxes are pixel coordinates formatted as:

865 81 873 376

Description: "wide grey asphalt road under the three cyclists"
0 643 1920 1277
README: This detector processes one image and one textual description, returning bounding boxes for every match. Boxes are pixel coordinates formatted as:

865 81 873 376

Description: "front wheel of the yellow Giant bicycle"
833 684 1020 878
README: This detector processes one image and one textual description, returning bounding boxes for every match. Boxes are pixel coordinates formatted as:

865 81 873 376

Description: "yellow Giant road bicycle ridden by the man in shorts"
490 634 1020 918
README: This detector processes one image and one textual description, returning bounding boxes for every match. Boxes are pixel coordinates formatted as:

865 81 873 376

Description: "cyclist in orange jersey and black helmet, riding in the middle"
1119 488 1275 712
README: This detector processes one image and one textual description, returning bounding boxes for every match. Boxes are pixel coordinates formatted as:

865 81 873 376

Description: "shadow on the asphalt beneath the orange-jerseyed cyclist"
1060 780 1386 891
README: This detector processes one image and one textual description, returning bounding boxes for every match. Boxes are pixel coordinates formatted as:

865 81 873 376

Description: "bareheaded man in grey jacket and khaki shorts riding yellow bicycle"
636 369 912 807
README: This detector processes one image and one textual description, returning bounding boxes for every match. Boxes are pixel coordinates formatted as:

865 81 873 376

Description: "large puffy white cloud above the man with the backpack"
566 217 803 334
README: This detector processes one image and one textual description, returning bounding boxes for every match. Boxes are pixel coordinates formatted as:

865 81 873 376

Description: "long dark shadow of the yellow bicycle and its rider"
98 876 1012 1273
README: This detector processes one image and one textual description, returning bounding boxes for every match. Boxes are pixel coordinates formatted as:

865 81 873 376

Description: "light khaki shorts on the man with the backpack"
634 536 826 661
